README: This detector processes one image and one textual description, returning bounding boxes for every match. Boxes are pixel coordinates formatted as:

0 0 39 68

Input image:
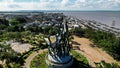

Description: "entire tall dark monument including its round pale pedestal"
46 19 73 68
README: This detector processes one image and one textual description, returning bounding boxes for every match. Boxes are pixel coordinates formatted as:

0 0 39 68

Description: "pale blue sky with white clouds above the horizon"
0 0 120 11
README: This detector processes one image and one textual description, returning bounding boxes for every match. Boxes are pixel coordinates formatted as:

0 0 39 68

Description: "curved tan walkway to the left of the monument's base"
23 49 47 68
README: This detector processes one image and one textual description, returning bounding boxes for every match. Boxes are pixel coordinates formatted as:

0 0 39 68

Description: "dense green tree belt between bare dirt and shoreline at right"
75 29 120 60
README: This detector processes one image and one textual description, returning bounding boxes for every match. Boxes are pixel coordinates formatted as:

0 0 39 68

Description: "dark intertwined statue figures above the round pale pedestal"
48 19 71 59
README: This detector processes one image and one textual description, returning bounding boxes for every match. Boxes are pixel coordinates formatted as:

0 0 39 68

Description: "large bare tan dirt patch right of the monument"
73 36 120 65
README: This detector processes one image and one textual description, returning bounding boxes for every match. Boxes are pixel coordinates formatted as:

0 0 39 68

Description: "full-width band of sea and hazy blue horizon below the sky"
0 10 120 28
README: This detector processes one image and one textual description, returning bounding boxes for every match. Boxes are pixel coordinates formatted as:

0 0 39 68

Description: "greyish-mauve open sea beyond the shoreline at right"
63 11 120 28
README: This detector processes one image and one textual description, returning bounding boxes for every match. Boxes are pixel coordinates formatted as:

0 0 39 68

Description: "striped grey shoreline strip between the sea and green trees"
68 16 120 37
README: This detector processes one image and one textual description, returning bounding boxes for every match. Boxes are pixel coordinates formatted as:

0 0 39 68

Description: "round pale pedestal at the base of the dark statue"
46 55 73 68
